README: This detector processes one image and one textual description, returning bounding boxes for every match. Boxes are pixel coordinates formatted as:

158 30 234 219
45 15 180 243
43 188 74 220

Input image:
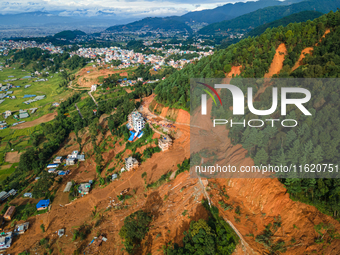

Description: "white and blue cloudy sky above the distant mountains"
0 0 250 17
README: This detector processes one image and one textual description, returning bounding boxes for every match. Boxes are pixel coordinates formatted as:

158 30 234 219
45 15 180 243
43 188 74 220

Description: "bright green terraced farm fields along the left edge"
0 56 80 167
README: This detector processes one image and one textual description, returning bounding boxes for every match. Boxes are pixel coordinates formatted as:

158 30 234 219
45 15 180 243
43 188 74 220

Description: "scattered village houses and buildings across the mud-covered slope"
0 104 173 252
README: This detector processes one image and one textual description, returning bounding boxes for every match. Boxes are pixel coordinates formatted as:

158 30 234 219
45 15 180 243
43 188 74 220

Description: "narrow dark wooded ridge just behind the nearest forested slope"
245 11 323 37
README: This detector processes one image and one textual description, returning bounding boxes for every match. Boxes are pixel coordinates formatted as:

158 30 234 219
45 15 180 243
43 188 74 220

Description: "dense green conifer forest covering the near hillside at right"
155 9 340 218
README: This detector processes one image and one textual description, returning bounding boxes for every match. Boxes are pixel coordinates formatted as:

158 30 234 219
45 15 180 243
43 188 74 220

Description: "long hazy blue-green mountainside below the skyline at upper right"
198 0 340 35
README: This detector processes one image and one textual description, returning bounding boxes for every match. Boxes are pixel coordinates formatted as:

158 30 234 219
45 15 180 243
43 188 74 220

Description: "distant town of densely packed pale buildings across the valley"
0 40 214 70
